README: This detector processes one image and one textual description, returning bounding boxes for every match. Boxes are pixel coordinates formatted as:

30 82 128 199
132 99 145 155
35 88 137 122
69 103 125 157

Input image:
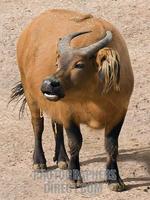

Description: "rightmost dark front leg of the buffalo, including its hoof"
105 119 125 191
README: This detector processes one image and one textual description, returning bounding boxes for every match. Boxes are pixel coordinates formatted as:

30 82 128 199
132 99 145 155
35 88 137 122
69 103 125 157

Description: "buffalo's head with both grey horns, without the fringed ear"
41 31 112 101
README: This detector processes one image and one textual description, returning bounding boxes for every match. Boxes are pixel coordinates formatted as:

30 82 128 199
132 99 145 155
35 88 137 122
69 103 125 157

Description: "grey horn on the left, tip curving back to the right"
58 31 91 54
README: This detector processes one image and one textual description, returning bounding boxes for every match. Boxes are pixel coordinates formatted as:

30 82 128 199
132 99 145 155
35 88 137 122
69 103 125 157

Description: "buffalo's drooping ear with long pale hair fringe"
96 47 120 93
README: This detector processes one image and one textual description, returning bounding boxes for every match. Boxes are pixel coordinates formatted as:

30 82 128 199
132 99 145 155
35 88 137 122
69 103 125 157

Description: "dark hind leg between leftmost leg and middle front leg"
52 121 69 169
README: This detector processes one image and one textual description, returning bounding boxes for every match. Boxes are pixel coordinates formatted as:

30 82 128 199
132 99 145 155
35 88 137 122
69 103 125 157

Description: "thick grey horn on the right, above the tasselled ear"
80 31 112 56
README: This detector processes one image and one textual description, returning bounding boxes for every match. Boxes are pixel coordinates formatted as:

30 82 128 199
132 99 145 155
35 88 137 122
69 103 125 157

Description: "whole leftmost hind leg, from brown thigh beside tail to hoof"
26 95 47 172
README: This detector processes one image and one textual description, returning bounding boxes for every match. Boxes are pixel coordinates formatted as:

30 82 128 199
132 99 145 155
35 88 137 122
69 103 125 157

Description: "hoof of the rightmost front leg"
108 181 127 192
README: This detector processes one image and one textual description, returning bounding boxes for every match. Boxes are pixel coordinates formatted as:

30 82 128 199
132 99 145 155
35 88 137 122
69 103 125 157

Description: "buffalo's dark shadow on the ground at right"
81 147 150 190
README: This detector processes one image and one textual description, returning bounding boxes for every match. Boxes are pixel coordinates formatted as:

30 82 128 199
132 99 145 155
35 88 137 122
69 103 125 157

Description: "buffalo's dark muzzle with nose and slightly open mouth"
41 80 65 101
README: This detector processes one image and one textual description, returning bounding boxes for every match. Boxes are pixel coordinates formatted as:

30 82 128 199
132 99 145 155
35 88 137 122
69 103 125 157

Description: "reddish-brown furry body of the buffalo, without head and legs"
17 10 133 131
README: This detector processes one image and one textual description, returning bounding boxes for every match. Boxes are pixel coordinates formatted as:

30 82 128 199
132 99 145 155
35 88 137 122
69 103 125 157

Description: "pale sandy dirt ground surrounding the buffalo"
0 0 150 200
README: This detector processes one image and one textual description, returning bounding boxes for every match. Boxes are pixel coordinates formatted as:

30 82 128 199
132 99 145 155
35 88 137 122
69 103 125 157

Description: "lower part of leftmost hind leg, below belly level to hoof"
32 117 46 171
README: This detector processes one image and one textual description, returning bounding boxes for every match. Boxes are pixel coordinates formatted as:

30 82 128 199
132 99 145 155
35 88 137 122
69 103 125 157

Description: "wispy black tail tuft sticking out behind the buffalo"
9 81 27 119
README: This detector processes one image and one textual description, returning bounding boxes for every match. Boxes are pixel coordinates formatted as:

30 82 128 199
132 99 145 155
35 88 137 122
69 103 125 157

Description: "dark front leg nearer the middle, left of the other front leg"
66 122 82 188
